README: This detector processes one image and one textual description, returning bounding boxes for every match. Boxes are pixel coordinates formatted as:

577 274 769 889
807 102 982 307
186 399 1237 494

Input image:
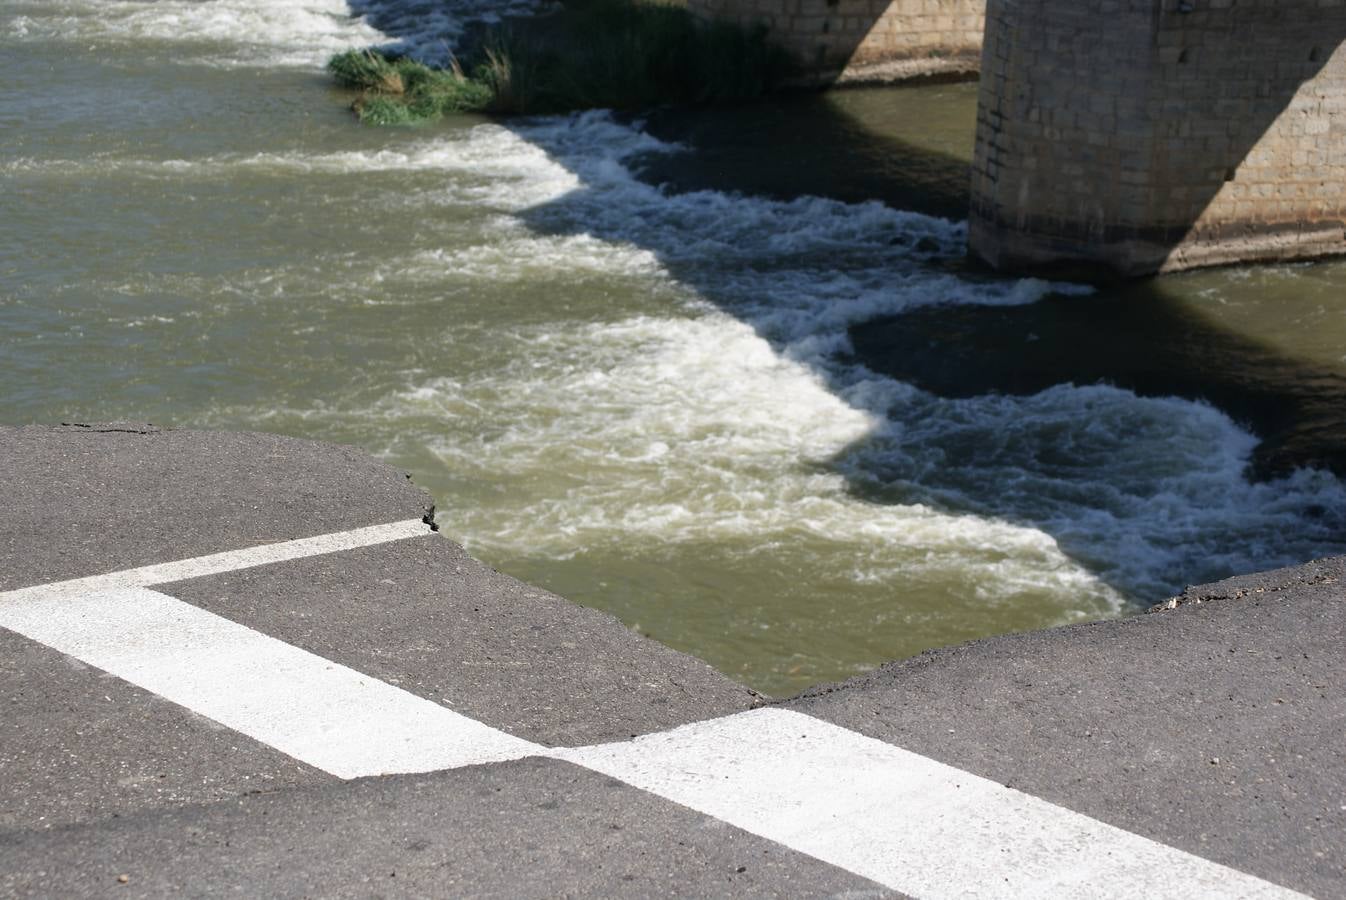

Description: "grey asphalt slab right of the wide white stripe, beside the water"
785 558 1346 897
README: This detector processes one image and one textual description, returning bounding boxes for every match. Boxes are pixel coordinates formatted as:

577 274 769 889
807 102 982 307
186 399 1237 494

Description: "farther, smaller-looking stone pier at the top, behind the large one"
688 0 987 83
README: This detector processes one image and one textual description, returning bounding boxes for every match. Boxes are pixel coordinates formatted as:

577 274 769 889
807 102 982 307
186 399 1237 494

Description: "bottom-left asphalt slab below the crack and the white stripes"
0 759 899 900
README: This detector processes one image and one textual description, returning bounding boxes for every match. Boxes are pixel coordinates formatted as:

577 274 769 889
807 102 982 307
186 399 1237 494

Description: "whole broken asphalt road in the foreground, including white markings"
0 425 1346 899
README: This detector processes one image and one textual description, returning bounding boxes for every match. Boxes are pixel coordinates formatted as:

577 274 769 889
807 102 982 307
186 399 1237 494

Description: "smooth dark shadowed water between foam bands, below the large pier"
851 280 1346 480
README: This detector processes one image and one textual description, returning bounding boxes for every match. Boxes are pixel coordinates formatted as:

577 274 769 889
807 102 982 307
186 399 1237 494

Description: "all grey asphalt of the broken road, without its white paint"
0 426 1346 899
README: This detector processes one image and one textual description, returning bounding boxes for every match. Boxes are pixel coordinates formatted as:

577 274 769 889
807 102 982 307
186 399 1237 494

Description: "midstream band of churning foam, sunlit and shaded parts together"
344 113 1346 607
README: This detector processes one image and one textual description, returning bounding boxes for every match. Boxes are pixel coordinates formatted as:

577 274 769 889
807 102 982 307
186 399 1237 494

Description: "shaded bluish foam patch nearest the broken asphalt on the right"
843 385 1346 600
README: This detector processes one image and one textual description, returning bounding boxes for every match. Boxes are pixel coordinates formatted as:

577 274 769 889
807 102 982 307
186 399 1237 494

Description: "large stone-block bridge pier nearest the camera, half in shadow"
969 0 1346 274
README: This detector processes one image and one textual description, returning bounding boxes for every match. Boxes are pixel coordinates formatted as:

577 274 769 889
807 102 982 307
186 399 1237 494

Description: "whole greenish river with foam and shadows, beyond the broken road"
0 0 1346 694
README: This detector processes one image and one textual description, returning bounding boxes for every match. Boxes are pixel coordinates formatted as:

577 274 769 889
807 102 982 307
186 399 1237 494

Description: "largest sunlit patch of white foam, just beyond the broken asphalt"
382 311 1121 615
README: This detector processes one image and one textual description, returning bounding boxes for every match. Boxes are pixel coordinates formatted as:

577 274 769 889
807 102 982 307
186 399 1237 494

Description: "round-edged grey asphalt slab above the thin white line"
0 425 432 591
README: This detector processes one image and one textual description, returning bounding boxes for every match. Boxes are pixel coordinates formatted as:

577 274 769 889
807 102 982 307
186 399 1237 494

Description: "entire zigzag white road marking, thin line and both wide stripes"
0 519 1303 900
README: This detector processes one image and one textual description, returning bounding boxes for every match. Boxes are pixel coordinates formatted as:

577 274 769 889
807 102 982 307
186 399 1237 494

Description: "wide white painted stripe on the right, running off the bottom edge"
549 709 1303 900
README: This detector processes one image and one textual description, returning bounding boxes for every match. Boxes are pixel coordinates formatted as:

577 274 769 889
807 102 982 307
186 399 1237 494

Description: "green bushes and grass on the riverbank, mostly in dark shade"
327 0 790 125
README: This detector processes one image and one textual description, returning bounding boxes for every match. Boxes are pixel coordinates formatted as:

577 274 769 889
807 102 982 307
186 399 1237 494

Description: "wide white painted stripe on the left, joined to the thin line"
0 588 542 778
